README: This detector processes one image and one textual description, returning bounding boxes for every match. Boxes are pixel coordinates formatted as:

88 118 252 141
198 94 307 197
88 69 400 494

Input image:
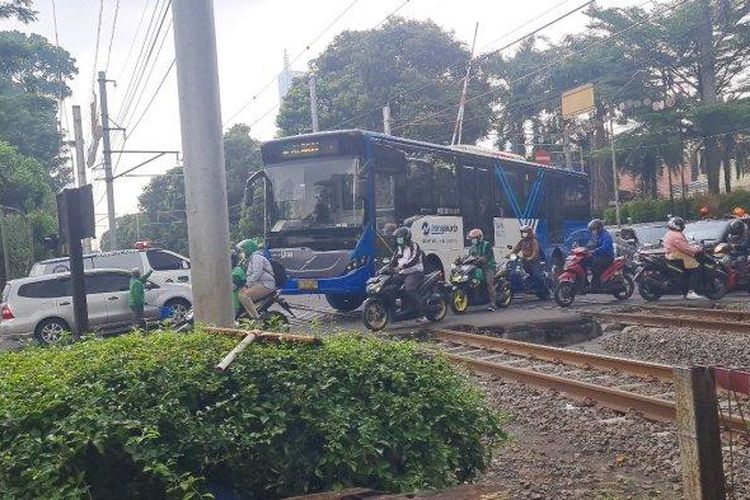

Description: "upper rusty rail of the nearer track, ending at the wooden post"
432 329 673 382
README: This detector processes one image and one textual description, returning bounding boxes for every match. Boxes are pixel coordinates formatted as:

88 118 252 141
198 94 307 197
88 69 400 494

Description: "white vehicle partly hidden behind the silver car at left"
29 248 190 285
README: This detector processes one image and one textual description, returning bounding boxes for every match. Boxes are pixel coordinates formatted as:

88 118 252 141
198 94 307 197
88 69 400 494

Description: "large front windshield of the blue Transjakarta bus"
266 157 366 232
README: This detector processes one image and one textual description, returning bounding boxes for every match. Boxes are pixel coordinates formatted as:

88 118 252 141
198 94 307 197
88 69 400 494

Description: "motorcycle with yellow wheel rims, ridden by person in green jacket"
448 255 512 314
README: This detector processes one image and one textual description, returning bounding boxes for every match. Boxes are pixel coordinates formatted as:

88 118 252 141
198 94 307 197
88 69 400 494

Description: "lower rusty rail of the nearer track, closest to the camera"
445 354 747 432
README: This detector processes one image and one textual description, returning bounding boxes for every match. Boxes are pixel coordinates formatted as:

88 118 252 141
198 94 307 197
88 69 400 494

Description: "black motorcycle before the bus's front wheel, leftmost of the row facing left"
362 265 448 332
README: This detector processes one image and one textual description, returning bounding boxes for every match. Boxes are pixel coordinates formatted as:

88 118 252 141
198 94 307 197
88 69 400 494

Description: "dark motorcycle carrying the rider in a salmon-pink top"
635 250 728 302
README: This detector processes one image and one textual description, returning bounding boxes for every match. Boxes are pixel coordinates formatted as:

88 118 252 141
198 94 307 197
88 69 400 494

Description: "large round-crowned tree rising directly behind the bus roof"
276 18 492 144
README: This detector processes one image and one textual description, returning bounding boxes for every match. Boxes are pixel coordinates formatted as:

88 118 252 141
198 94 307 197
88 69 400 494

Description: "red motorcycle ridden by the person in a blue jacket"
555 247 635 307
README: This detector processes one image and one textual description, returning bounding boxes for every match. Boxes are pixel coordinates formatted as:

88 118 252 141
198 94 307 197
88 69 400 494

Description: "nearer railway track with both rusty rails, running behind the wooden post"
433 329 746 431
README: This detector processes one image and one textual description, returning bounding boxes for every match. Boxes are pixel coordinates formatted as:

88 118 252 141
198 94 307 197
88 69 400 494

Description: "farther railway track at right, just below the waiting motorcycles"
581 306 750 334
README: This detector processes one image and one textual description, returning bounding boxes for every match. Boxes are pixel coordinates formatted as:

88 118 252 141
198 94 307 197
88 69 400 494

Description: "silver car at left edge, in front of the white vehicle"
0 269 193 344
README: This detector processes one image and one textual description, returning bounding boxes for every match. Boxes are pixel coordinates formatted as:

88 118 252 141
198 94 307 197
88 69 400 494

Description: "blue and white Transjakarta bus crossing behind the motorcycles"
253 130 590 310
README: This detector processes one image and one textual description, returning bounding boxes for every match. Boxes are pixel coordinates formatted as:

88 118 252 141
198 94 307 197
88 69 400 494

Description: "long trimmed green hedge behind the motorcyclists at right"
604 189 750 224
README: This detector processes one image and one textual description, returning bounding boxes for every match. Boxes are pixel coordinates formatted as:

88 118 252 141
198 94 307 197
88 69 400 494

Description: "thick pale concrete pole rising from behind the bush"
172 0 234 327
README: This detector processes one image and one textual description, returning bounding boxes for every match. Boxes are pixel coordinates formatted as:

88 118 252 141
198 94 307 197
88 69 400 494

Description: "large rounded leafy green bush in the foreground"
0 333 504 498
